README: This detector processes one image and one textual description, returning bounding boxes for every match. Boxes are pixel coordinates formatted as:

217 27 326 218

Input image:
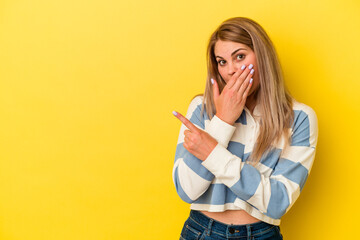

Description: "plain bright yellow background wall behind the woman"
0 0 360 240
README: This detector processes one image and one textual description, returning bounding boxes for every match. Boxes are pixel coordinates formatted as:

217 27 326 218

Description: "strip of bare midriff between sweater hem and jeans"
201 210 261 225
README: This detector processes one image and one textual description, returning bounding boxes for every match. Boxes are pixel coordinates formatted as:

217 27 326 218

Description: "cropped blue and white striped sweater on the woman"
172 96 318 225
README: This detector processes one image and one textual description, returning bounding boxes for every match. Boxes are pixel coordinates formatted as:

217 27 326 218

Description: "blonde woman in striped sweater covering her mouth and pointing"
173 17 318 239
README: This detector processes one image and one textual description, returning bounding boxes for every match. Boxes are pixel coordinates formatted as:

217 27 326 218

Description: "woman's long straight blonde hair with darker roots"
201 17 294 165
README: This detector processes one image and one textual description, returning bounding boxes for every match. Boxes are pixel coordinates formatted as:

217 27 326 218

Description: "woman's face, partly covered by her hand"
214 40 259 96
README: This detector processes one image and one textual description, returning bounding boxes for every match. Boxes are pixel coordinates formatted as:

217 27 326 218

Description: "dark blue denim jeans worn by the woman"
180 210 283 240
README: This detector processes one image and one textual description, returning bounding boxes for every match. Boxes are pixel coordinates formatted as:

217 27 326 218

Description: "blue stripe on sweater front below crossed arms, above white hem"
194 183 236 205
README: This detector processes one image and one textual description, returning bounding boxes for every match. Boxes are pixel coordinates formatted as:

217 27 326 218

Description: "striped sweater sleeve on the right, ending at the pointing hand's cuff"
202 106 318 219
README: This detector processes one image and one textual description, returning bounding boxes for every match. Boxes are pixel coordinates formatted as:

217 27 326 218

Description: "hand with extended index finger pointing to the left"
173 111 218 161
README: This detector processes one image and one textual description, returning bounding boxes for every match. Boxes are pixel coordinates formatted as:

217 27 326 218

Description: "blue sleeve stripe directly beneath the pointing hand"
175 143 214 181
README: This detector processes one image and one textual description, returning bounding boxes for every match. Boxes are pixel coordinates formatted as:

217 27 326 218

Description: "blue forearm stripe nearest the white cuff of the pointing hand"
230 164 261 201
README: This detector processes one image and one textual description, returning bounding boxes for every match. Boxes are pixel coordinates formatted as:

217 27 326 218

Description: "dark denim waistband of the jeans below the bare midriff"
190 210 274 237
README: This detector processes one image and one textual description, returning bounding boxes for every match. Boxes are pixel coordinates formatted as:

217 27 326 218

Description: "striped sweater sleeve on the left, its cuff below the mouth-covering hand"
172 97 236 203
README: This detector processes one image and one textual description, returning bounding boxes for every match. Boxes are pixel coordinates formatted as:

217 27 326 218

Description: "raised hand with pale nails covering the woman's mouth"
212 66 254 125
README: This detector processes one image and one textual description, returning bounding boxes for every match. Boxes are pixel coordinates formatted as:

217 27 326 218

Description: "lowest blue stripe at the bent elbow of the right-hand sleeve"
266 178 289 219
